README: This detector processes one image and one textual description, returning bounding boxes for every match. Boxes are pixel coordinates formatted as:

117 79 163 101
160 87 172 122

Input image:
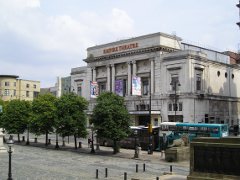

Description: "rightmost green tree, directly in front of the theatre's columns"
91 92 131 154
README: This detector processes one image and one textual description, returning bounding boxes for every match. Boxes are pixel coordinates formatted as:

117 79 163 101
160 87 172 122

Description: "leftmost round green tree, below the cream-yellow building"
1 100 31 141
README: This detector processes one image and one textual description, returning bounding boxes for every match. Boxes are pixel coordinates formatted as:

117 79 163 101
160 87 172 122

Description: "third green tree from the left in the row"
56 93 88 148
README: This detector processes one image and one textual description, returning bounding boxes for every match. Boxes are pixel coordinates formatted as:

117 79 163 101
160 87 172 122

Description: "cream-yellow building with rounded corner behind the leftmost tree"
0 75 40 101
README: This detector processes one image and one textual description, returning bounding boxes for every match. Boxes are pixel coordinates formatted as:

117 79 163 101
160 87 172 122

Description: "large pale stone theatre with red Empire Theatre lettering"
76 33 240 125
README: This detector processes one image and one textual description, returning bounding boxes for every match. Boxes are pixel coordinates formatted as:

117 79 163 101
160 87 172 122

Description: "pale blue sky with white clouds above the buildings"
0 0 240 88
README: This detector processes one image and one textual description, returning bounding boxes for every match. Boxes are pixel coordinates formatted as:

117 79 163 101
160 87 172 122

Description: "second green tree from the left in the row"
30 93 57 145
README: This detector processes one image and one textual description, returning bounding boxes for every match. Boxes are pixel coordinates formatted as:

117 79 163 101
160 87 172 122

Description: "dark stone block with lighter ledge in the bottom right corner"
187 137 240 180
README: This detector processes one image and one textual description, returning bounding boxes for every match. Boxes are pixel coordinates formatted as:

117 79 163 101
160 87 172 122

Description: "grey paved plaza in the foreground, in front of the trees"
0 137 189 180
